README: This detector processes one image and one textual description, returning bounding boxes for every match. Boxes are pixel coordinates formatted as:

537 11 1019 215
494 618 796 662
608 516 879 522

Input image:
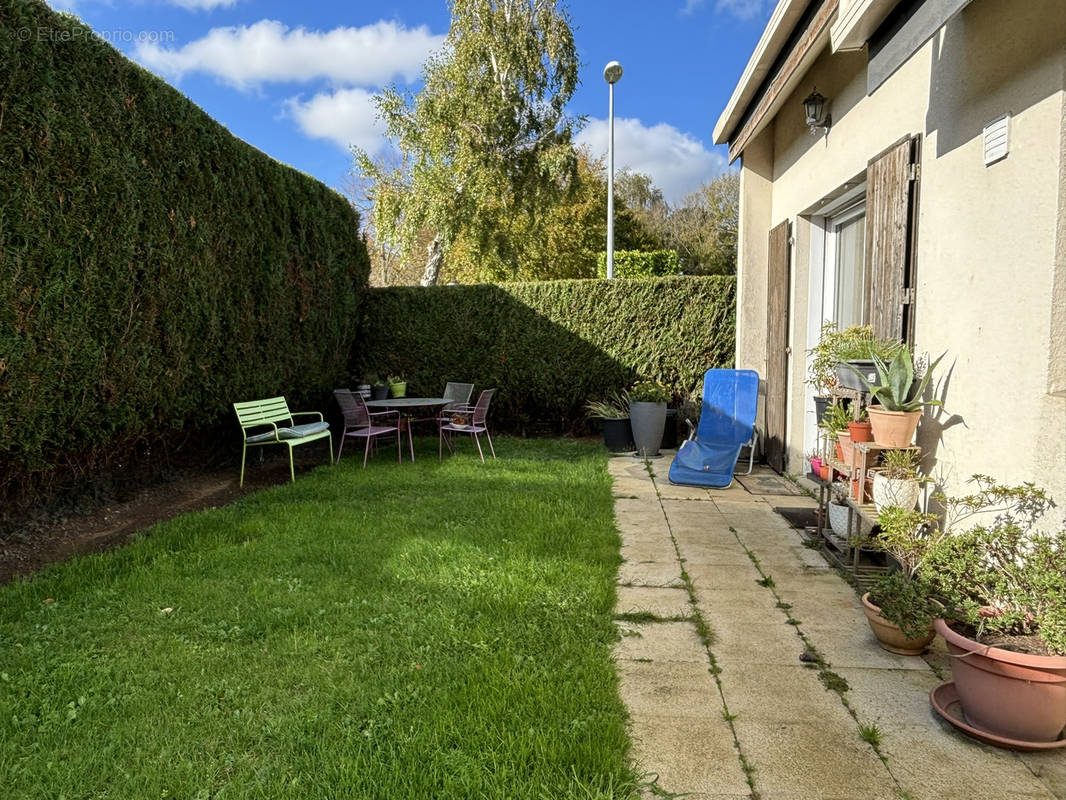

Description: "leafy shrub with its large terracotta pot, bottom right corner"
919 475 1066 749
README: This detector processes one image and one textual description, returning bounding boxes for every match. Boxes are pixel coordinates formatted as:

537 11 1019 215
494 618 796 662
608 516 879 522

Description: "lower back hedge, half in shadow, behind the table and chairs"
352 276 737 432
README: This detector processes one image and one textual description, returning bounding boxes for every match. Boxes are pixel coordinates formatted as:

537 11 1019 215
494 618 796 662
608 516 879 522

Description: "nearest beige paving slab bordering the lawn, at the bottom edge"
631 714 750 800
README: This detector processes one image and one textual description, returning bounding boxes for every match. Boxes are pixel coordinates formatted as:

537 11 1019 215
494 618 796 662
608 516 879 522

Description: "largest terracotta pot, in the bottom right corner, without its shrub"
934 620 1066 742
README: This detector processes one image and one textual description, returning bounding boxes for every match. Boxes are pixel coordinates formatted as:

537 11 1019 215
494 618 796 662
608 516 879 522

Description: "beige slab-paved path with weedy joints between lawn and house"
610 457 1066 800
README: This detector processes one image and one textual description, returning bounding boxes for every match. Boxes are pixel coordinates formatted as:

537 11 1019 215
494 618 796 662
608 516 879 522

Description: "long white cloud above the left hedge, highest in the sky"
136 20 445 87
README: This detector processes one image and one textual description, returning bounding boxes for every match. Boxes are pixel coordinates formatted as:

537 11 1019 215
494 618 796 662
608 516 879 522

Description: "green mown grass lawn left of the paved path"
0 439 635 800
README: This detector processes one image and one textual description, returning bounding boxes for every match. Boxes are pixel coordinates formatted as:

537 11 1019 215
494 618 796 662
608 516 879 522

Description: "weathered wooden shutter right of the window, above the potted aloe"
866 137 919 341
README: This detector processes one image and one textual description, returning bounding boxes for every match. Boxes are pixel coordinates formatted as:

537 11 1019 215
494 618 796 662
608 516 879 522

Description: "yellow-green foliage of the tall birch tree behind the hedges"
355 0 578 283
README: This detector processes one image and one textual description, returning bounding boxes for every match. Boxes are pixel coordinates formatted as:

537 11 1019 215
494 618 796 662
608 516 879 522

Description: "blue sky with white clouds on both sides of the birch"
49 0 774 202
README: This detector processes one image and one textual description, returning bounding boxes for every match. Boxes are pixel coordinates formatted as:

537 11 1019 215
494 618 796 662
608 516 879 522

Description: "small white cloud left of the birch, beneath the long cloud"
285 89 385 155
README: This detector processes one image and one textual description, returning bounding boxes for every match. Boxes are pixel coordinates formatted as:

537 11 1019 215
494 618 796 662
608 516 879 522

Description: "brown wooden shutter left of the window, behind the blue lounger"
762 220 791 473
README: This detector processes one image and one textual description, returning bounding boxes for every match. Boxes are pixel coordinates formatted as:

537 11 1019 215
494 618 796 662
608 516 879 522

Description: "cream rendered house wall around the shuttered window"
738 0 1066 503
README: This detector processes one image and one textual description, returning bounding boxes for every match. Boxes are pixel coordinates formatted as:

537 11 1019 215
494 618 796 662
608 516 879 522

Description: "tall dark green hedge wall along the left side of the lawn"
0 0 369 500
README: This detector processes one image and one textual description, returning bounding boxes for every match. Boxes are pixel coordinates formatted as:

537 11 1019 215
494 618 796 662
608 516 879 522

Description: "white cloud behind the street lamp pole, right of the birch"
577 117 728 208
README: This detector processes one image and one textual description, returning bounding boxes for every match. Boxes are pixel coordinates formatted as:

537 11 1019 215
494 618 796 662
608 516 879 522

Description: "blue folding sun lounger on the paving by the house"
669 369 759 489
